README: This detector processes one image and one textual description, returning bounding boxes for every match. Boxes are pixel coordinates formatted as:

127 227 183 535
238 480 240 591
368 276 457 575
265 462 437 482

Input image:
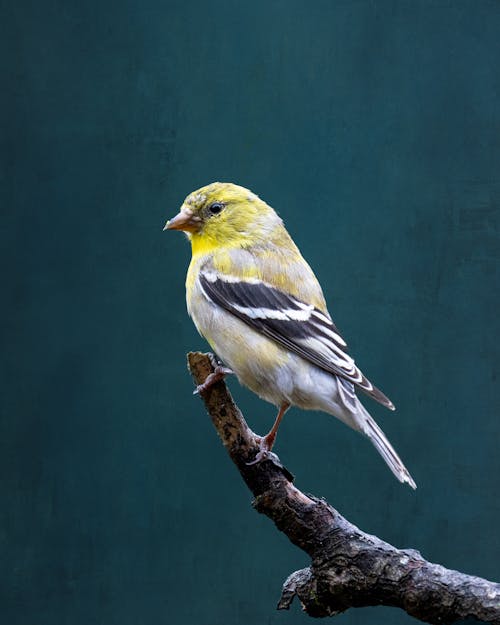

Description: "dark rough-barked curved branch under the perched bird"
188 352 500 625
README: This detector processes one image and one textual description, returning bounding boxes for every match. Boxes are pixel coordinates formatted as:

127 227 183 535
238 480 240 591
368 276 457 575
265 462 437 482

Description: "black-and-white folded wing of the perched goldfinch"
199 269 394 410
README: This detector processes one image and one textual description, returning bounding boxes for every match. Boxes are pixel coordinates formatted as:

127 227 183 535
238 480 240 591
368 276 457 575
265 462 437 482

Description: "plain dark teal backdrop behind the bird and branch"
0 0 500 625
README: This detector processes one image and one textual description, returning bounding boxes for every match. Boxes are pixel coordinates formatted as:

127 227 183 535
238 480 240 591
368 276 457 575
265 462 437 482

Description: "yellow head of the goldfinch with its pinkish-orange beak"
164 182 282 251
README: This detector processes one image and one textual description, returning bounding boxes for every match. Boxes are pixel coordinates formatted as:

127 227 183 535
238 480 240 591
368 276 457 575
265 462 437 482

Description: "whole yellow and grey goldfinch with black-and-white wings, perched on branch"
165 182 416 488
